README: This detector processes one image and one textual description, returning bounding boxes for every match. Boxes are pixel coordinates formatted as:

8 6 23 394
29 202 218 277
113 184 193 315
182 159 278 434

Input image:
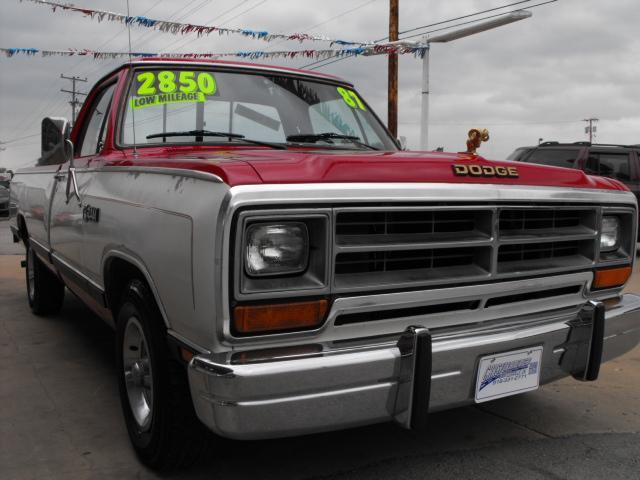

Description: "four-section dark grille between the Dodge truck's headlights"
334 206 599 292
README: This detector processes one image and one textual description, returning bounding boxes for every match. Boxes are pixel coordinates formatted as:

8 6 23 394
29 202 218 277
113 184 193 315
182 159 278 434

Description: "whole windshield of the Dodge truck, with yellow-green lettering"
121 67 397 150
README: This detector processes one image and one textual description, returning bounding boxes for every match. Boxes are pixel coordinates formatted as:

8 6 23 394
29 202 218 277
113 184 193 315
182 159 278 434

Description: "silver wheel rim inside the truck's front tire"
122 317 153 431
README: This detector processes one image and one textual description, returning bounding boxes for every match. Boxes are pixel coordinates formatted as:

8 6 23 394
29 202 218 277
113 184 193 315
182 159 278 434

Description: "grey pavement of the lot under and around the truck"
0 222 640 480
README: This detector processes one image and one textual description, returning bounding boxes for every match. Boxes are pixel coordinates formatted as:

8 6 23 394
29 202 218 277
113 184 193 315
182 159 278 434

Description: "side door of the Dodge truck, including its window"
50 83 115 296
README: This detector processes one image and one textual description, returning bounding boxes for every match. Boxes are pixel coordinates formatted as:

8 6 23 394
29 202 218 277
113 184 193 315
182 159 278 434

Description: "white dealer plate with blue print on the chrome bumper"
476 347 542 403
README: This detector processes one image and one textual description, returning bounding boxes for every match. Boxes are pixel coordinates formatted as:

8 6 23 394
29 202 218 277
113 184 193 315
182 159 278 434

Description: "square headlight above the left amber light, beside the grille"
245 222 309 277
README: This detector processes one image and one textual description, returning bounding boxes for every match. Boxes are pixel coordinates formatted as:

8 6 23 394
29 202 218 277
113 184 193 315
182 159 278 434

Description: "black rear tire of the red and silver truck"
25 242 64 316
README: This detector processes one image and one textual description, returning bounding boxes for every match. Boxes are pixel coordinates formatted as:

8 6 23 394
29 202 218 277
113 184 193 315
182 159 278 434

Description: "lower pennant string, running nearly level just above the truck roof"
0 42 429 60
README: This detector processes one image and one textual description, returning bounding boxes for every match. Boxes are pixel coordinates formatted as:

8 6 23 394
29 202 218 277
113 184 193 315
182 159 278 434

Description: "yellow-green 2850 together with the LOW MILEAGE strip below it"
131 70 218 109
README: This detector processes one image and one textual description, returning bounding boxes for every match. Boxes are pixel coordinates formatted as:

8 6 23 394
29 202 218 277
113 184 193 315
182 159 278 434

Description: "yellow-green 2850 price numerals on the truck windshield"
136 70 218 96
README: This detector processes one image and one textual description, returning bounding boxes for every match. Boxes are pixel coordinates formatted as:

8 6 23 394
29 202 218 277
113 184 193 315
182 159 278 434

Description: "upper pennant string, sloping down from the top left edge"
20 0 374 46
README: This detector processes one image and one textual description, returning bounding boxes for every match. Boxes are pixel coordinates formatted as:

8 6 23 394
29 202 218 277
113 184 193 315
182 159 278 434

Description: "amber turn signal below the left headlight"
233 300 327 334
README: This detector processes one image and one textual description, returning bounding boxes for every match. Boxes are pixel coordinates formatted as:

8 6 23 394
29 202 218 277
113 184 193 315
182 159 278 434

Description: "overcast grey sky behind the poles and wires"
0 0 640 168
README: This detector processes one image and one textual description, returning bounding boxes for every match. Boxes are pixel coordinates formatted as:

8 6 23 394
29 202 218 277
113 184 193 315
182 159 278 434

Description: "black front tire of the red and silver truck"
116 280 212 471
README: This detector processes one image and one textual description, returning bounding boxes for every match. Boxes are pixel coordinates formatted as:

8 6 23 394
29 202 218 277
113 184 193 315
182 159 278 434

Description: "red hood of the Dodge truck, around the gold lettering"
109 147 627 190
